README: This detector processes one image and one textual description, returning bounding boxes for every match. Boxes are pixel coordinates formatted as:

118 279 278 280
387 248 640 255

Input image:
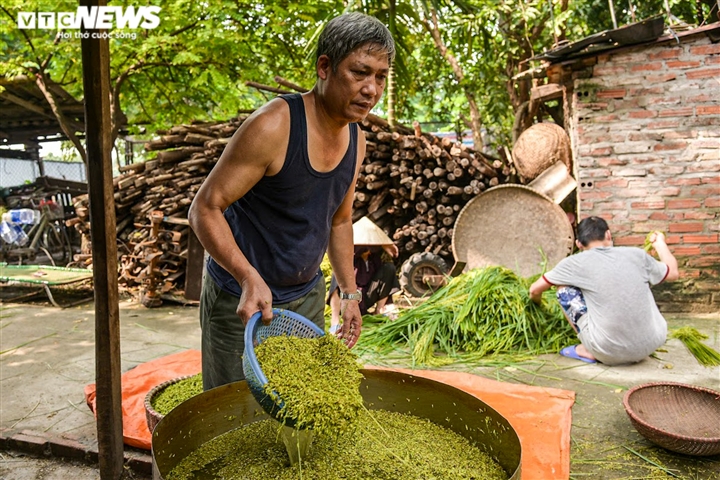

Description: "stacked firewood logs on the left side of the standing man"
66 116 247 296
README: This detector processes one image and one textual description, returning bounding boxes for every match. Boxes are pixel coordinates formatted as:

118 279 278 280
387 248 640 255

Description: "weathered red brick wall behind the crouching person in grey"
564 28 720 311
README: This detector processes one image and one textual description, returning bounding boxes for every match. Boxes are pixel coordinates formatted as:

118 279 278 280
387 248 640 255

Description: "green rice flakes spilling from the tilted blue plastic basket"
255 335 363 434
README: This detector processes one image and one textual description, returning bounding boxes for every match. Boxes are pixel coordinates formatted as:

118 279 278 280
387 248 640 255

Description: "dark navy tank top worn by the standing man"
207 94 358 303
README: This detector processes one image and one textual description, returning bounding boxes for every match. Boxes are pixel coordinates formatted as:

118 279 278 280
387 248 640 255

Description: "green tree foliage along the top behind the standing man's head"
0 0 711 146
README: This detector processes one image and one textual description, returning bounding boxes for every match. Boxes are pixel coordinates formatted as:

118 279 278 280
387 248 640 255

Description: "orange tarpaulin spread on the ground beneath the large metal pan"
85 350 575 480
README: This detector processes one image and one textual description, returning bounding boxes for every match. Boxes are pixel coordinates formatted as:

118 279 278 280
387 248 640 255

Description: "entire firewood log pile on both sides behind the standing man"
67 115 514 303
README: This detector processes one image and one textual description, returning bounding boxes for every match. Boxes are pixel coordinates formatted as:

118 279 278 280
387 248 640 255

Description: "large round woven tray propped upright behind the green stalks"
452 185 575 277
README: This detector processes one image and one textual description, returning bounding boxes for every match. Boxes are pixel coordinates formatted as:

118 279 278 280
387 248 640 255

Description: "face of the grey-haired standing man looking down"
318 45 390 122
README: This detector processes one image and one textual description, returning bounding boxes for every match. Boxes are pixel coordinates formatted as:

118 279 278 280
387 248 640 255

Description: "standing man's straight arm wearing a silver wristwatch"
328 129 365 348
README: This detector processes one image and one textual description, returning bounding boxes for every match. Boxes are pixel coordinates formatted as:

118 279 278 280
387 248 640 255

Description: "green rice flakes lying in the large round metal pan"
167 410 509 480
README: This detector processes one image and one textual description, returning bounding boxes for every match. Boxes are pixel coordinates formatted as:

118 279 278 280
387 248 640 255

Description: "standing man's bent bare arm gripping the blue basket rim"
188 99 290 323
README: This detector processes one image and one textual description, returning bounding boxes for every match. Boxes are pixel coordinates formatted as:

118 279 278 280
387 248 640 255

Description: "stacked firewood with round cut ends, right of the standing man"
353 118 514 261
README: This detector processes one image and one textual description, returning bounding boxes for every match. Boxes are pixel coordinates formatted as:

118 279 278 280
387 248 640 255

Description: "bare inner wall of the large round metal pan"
152 369 521 480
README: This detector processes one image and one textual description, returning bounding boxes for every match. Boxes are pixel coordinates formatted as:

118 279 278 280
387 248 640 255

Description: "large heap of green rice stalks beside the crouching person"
359 266 575 366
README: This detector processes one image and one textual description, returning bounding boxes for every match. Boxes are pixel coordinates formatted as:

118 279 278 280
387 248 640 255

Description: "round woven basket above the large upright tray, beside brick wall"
512 122 572 182
